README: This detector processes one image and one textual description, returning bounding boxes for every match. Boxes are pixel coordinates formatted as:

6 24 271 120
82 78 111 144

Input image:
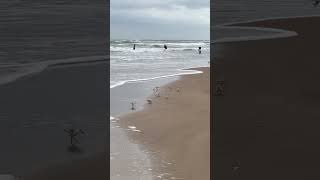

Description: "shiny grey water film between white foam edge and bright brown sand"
110 76 178 180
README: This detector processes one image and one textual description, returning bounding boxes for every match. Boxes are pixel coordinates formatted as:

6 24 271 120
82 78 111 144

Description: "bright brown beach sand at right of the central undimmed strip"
120 68 210 180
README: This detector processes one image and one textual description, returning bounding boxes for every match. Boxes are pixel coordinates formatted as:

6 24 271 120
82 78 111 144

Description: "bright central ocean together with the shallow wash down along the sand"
110 40 210 180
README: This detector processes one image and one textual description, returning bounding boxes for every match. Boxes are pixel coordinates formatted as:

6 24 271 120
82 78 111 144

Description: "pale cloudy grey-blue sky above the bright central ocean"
110 0 210 40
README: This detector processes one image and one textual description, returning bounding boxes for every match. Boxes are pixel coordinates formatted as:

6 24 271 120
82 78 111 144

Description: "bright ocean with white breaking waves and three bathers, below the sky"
110 40 210 88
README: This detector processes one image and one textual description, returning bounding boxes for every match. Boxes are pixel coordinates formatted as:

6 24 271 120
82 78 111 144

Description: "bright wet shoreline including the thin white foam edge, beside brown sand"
110 68 209 180
